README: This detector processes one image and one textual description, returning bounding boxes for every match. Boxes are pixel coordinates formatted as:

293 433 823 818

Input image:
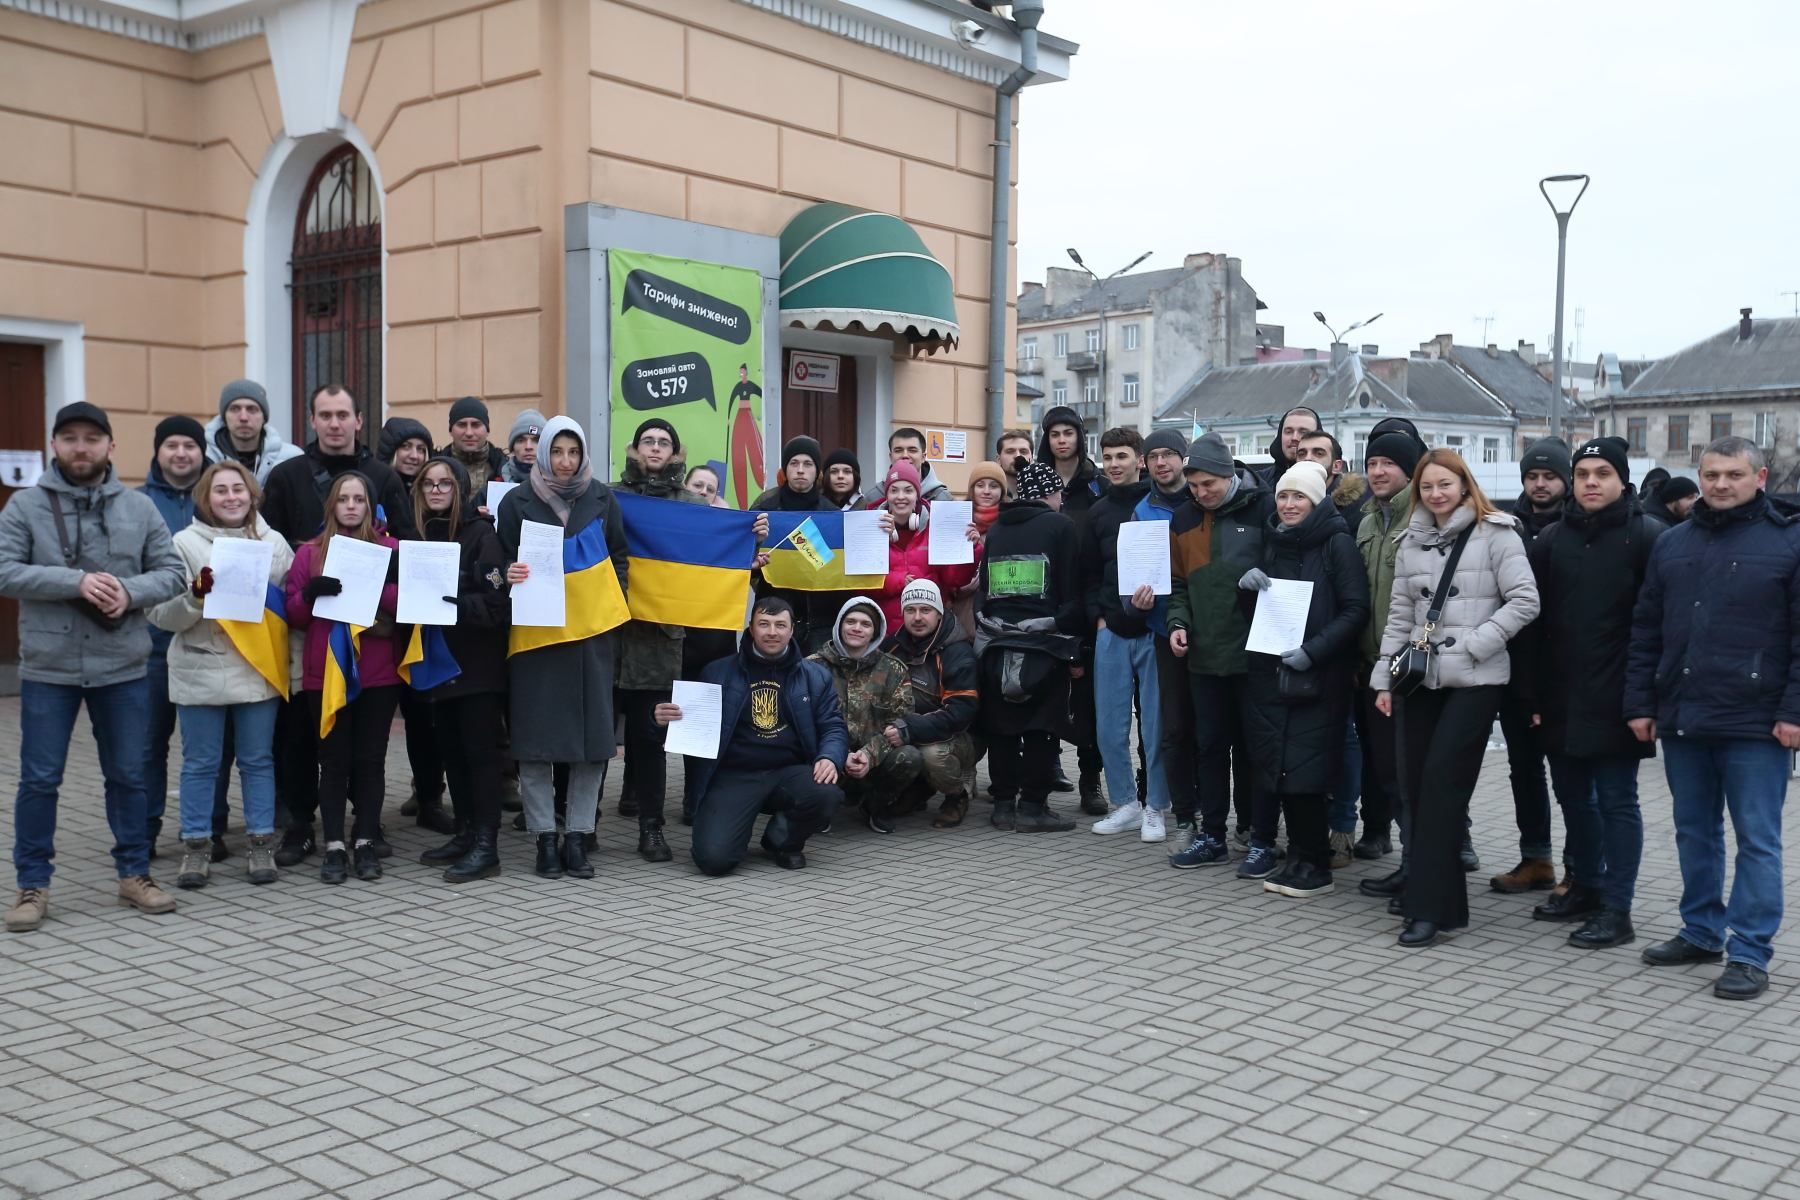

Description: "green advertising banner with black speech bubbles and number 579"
607 250 765 509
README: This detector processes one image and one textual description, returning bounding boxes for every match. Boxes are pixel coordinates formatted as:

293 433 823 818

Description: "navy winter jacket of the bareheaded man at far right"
1625 493 1800 739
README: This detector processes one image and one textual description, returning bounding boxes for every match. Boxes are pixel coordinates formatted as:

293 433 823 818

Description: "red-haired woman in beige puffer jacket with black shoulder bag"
1368 450 1539 946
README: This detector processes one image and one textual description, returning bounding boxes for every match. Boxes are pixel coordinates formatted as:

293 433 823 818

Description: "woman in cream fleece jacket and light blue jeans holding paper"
149 459 293 887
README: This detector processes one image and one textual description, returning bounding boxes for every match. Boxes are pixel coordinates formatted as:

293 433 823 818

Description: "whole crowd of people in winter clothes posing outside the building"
0 390 1800 999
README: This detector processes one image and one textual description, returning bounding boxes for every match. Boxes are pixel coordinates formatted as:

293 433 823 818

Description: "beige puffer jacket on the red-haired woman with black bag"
1368 504 1537 691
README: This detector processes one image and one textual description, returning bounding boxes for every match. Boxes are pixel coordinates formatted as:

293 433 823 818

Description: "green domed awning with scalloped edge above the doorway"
781 203 961 353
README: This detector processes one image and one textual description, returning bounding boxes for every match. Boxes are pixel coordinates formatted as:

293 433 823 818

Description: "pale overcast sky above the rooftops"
1019 0 1800 360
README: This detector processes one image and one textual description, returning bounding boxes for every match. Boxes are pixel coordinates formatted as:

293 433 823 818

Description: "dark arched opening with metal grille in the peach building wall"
288 146 382 446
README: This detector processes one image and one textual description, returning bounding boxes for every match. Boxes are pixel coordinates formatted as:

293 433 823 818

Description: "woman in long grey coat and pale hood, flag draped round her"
499 417 626 880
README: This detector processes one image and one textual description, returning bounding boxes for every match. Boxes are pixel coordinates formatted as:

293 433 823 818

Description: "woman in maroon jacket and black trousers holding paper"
288 471 400 883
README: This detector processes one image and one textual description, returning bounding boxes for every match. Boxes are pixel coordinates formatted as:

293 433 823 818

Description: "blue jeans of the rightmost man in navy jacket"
1663 738 1787 970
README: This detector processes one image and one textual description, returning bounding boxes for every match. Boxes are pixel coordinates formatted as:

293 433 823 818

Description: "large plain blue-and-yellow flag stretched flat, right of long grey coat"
612 491 758 631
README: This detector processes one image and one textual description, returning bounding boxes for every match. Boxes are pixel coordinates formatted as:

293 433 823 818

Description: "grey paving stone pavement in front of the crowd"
0 698 1800 1200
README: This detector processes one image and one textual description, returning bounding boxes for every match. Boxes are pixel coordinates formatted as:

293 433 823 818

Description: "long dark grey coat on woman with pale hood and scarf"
495 479 630 763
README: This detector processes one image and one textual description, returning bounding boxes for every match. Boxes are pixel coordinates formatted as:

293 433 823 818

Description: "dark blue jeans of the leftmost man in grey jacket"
13 678 149 887
